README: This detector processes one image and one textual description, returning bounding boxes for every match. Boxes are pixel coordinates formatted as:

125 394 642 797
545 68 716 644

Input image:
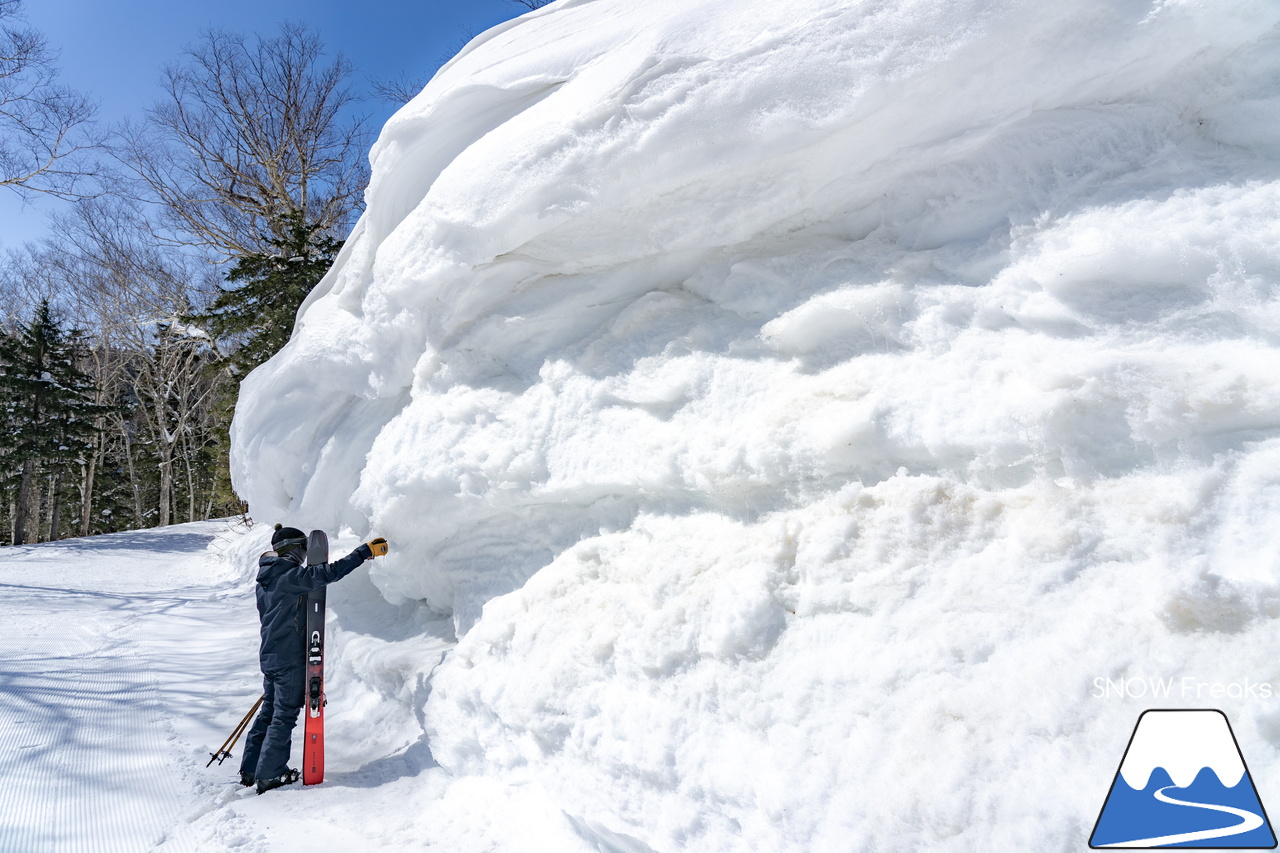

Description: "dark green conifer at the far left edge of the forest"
0 300 105 544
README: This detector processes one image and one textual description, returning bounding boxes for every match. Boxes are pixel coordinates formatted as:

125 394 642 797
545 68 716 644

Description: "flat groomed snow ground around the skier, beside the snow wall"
0 521 460 853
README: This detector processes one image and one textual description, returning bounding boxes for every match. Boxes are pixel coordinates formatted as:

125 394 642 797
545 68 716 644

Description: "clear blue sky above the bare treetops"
0 0 526 248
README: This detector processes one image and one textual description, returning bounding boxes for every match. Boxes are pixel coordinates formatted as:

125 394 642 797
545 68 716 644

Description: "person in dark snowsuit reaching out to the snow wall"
241 525 387 794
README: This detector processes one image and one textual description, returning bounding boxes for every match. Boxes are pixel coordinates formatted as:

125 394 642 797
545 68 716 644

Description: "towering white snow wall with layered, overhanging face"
233 0 1280 853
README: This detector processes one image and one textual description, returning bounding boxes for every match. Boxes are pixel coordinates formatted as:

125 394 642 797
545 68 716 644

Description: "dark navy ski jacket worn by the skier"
257 544 374 674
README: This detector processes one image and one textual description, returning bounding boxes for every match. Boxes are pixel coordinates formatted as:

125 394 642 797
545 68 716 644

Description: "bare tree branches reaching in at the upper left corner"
0 0 101 199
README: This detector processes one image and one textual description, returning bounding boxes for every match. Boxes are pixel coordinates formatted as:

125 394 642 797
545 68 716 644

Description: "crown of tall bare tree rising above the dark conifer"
123 24 369 259
